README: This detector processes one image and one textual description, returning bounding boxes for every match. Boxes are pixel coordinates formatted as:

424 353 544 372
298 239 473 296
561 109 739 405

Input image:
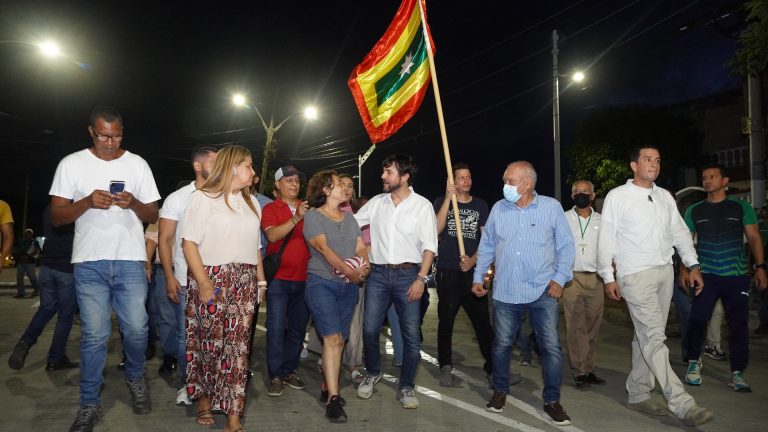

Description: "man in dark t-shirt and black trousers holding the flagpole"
434 163 493 386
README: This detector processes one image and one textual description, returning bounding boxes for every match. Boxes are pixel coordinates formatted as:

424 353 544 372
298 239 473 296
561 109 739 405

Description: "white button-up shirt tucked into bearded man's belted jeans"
355 187 437 264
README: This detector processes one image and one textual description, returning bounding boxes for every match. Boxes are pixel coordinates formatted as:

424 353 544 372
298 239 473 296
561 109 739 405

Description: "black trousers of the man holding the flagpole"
437 270 493 374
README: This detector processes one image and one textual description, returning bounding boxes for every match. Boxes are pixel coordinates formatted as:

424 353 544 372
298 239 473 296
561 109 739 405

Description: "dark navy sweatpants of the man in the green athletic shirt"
688 273 749 371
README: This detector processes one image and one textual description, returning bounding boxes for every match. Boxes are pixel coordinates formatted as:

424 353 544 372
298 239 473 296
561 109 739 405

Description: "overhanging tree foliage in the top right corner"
728 0 768 76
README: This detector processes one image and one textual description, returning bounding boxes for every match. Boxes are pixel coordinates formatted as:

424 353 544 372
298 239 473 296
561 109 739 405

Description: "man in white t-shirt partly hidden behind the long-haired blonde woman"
158 145 218 405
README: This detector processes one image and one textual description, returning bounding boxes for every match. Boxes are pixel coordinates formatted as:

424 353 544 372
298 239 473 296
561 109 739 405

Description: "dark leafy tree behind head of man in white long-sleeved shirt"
565 105 703 196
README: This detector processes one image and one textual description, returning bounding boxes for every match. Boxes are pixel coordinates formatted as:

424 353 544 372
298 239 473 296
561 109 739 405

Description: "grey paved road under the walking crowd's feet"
0 269 768 432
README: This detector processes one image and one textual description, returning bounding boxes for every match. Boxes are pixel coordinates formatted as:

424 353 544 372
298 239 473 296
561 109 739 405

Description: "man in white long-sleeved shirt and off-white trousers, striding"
597 146 714 426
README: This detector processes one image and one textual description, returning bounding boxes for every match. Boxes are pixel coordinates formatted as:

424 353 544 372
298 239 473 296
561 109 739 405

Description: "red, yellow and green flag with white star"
348 0 435 144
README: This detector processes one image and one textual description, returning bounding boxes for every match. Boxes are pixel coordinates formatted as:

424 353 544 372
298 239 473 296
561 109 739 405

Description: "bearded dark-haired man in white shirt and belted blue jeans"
355 154 437 408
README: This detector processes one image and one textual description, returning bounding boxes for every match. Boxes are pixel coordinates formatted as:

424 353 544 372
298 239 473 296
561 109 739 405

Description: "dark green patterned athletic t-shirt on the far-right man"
684 198 757 276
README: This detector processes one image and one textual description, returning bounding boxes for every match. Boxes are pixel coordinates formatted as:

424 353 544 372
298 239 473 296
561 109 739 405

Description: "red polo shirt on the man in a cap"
261 198 309 281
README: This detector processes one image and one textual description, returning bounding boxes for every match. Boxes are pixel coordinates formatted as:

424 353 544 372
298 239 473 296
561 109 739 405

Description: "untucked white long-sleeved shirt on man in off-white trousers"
597 179 698 283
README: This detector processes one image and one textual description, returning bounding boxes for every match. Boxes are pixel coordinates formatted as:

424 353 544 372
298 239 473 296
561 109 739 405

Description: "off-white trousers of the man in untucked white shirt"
618 265 696 419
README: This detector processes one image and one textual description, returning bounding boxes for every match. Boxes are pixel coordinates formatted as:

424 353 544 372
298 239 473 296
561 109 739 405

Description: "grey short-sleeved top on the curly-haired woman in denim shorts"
304 209 362 279
